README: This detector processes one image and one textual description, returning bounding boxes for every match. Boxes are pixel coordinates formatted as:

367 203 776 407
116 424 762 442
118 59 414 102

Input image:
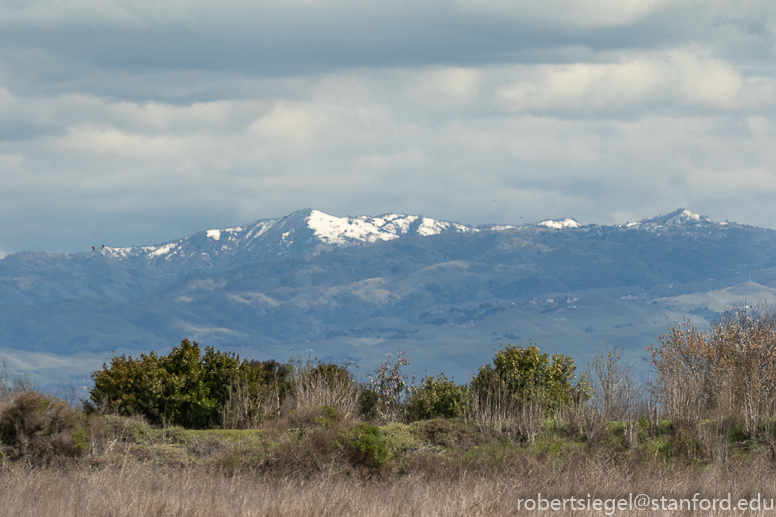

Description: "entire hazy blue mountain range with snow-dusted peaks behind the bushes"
0 209 776 390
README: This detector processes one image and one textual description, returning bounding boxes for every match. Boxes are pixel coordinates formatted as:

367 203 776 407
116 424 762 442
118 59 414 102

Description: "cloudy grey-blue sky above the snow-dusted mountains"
0 0 776 256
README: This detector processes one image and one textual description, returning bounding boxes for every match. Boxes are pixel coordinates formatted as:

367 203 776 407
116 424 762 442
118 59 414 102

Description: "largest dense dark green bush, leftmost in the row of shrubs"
89 339 290 428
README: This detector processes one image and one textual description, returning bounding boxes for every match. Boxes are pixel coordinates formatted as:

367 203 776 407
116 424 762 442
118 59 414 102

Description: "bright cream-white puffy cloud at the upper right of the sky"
496 49 776 115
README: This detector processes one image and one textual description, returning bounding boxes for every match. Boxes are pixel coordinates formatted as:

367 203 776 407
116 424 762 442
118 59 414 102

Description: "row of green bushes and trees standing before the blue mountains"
86 339 588 429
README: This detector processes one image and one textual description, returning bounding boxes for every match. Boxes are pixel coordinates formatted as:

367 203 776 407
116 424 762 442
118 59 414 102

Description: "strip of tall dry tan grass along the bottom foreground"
7 454 776 517
